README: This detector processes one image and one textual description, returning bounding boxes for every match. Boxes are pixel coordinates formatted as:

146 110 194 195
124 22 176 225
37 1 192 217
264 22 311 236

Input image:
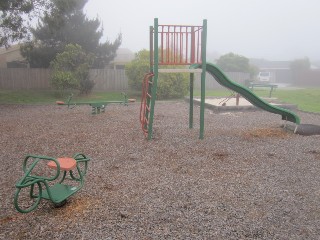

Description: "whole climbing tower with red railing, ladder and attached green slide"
140 18 300 140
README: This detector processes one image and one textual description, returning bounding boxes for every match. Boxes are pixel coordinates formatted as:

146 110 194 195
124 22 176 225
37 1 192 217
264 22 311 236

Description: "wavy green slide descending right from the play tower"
191 63 300 124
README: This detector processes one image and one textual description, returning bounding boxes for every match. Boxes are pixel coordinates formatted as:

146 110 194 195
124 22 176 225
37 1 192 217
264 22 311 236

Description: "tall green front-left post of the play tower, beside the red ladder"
148 18 159 140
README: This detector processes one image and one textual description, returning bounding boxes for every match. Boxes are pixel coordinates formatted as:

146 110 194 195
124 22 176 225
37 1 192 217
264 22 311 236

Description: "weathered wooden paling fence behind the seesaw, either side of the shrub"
0 68 128 91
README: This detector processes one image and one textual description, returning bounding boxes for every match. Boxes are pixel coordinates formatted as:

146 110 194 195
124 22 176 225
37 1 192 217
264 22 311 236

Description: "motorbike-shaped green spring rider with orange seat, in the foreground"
14 153 90 213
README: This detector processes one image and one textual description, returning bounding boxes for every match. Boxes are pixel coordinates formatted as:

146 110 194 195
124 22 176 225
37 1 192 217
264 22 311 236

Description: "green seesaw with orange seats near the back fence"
56 92 130 114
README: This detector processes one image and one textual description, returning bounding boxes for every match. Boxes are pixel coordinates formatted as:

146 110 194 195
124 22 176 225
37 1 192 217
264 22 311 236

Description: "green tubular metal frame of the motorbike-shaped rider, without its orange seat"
14 153 90 213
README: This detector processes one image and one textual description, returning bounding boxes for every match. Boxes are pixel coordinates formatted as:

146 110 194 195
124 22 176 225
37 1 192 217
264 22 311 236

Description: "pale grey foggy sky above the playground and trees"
84 0 320 60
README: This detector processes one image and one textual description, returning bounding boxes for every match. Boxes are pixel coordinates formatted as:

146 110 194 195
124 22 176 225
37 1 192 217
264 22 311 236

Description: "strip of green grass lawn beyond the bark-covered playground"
0 88 320 113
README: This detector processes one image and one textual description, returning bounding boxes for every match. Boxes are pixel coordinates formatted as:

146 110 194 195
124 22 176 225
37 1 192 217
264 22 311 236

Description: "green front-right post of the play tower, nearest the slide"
199 19 207 139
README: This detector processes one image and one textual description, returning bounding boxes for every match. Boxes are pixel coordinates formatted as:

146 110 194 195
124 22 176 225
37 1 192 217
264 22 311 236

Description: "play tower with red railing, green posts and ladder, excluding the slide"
140 18 207 140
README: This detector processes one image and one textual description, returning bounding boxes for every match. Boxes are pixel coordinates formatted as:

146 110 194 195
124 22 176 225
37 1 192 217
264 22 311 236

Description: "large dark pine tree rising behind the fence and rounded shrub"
21 0 122 68
